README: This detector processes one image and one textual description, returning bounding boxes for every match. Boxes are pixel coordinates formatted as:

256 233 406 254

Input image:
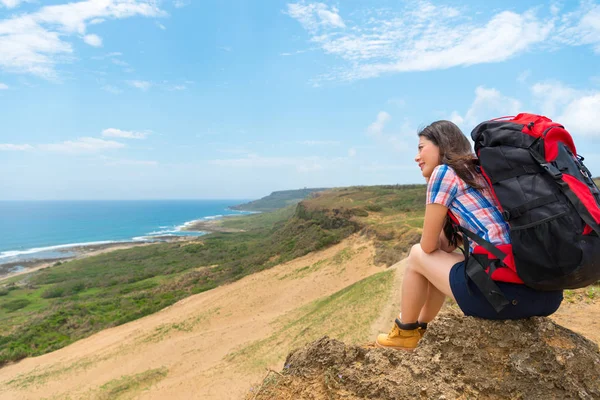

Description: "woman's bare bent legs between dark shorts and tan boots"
401 244 464 323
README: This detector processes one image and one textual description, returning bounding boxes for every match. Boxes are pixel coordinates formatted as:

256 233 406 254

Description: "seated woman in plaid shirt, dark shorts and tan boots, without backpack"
376 121 562 350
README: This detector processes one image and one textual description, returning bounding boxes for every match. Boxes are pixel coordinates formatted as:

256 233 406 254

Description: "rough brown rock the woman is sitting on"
246 314 600 400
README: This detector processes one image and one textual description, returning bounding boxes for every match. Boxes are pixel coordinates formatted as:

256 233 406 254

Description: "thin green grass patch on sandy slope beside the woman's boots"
226 270 394 371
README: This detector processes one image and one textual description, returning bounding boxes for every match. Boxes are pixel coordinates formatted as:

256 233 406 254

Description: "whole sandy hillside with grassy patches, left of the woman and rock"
0 234 401 400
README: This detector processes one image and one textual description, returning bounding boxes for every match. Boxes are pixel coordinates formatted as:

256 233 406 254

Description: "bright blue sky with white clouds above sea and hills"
0 0 600 200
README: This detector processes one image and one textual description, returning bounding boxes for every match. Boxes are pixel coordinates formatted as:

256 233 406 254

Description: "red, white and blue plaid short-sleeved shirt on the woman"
427 164 510 252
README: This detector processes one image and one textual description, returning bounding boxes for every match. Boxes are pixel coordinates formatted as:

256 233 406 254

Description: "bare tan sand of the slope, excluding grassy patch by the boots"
0 236 384 399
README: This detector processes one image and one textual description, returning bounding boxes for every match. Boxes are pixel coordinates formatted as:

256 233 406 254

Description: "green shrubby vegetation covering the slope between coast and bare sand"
0 185 425 365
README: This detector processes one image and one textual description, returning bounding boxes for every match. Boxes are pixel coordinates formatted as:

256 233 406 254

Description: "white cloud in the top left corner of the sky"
0 0 165 79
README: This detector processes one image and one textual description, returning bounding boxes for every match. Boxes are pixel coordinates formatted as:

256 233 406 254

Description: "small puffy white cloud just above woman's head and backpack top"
450 86 522 130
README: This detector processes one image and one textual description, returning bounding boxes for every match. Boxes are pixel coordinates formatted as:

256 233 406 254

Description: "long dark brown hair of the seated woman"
418 120 484 246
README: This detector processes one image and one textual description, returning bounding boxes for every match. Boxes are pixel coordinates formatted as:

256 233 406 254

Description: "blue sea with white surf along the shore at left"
0 200 252 264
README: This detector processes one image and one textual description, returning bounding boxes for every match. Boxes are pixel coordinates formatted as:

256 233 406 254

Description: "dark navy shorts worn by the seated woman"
450 261 563 319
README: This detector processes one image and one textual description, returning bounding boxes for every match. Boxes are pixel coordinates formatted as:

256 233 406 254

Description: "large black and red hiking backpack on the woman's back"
457 114 600 312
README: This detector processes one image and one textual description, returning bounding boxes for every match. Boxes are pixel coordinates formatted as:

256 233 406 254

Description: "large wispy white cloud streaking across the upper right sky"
285 0 600 83
